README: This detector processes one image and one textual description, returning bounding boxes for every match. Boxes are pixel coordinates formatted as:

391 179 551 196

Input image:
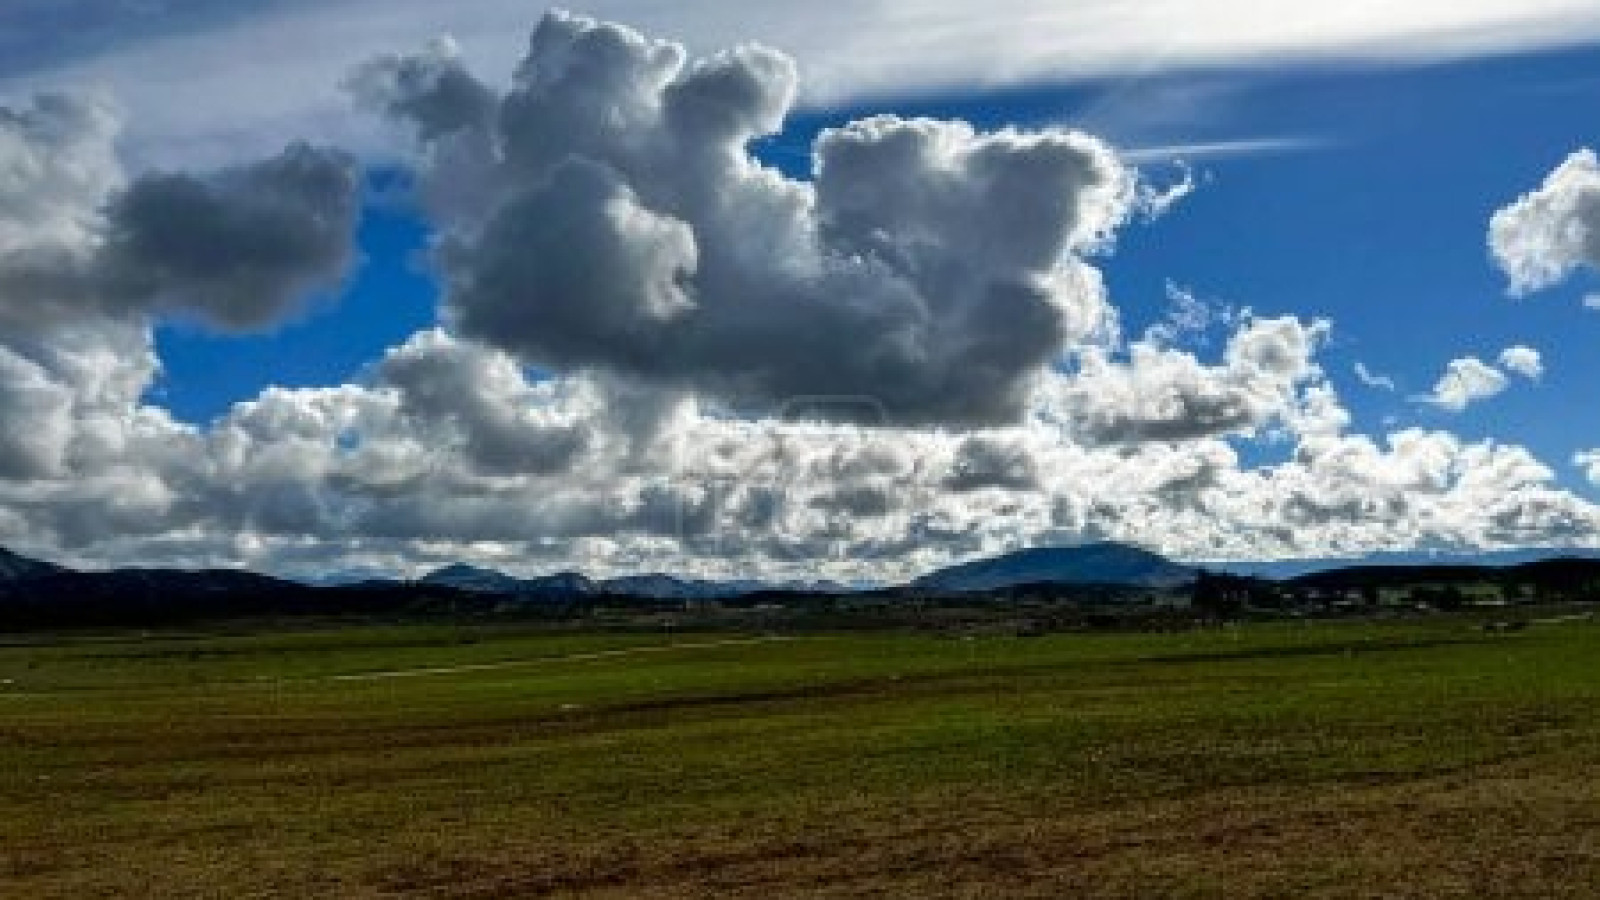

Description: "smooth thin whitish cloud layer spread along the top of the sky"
9 0 1600 165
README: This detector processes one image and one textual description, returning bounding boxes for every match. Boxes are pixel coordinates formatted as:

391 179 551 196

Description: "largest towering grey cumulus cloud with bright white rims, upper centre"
395 14 1134 424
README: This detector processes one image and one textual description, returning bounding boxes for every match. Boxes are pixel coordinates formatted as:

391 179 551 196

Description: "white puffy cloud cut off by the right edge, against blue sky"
1490 149 1600 296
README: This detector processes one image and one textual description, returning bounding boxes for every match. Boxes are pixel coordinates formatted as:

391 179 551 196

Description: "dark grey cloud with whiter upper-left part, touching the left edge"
0 96 360 330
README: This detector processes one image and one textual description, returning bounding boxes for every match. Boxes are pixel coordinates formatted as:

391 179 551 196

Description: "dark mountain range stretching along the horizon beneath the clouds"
0 543 1600 631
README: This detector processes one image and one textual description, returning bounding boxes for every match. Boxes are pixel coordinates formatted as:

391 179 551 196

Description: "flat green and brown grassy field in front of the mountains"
0 618 1600 900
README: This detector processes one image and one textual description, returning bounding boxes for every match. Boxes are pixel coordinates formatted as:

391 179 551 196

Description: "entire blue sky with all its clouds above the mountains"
0 0 1600 581
